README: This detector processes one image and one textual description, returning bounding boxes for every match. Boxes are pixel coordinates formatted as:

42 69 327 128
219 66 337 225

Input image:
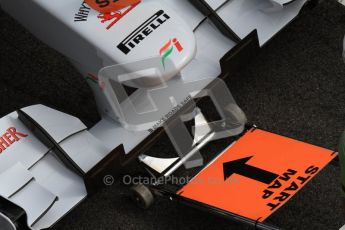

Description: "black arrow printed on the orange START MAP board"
223 156 278 184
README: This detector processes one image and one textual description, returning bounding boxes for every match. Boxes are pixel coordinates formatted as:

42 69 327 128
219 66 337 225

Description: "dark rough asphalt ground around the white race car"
0 0 345 230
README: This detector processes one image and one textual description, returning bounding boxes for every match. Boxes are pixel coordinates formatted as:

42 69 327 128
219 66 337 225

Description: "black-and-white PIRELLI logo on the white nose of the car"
117 10 170 55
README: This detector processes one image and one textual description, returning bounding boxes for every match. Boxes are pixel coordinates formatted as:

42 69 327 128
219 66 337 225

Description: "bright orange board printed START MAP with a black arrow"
178 129 337 222
